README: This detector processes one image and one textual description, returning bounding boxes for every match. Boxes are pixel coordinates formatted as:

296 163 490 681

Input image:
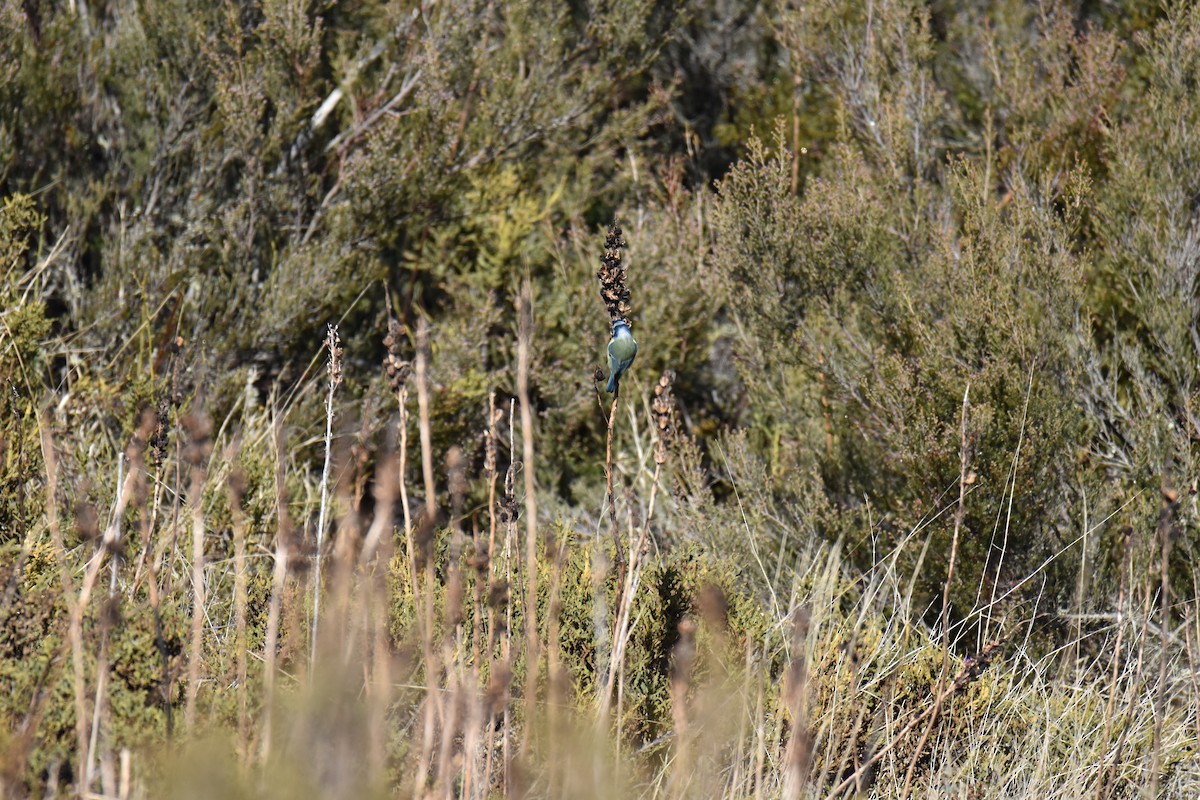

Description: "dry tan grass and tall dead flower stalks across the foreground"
0 227 1200 800
